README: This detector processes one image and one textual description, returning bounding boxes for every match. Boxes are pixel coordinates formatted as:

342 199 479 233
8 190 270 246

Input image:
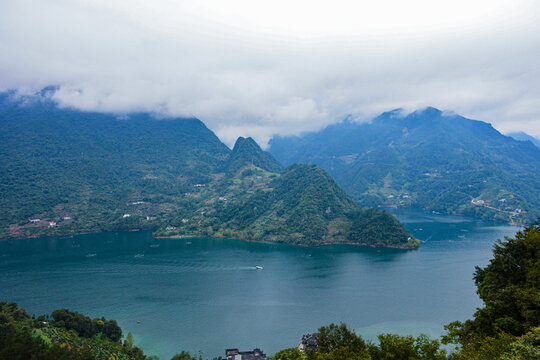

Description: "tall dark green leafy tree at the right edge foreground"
443 221 540 359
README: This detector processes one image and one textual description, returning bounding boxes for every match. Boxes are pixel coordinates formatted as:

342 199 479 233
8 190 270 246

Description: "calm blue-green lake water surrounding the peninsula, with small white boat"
0 211 517 359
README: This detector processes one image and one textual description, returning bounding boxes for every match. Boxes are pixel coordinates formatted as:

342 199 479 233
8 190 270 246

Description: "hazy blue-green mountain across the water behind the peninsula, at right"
269 108 540 223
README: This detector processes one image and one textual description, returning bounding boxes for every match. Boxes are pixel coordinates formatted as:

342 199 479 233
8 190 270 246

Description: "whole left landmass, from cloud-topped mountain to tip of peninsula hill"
0 93 417 247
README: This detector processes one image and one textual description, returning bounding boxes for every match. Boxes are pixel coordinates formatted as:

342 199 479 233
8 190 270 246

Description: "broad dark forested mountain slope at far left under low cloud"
0 94 230 238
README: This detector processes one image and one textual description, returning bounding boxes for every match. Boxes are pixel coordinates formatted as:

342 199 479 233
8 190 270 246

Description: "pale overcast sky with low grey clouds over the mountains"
0 0 540 146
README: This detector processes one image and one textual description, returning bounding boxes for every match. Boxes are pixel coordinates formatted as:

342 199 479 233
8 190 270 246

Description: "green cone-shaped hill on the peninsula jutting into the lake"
156 165 419 248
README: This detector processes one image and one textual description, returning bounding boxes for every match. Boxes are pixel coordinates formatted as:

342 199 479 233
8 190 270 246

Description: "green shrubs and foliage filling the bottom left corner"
0 302 152 360
